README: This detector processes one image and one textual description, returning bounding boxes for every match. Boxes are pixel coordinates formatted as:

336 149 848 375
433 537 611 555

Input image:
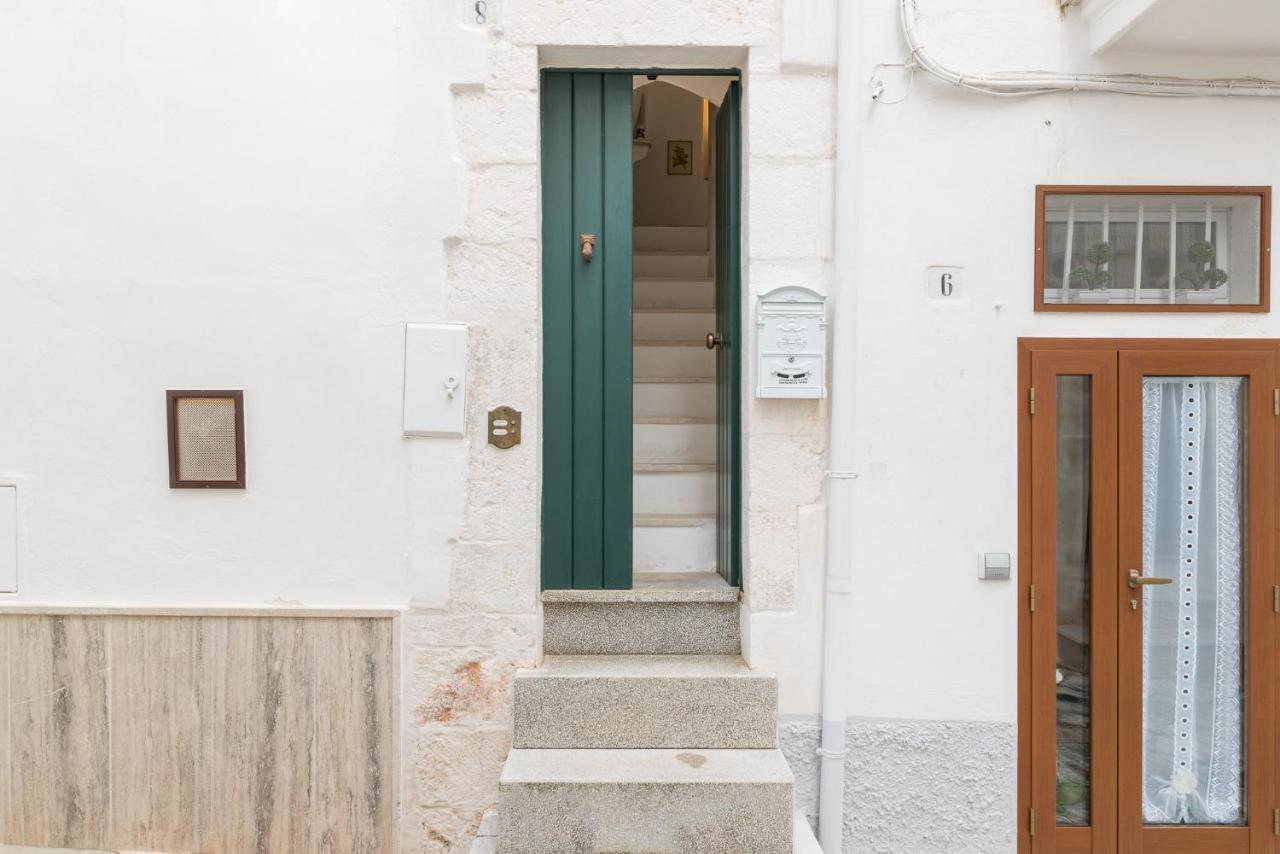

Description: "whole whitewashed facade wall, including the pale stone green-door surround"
0 0 1280 850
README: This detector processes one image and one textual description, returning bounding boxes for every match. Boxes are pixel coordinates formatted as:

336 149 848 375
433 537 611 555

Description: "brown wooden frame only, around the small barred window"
1034 184 1271 314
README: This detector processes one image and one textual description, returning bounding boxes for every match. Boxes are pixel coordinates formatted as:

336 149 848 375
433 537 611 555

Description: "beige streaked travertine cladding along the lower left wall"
0 615 398 854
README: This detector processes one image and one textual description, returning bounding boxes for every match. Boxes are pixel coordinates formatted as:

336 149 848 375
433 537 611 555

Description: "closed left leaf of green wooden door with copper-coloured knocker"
541 72 632 590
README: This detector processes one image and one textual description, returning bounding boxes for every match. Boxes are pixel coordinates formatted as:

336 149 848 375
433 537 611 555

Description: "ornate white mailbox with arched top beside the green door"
755 287 827 398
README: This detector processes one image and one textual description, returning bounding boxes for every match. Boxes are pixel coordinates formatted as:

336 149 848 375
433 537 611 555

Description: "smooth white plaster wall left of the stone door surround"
0 0 483 606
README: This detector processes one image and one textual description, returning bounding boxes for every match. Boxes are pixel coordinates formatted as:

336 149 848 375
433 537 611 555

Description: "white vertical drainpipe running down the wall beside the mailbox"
818 0 864 854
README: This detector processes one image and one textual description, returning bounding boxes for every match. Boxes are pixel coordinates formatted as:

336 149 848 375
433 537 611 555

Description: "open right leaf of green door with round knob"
716 82 746 585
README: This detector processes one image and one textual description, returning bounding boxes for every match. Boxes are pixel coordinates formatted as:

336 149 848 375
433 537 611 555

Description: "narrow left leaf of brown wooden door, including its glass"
1028 351 1116 853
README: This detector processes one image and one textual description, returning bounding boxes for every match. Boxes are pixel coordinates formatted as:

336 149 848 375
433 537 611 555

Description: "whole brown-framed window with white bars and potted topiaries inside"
1036 186 1271 312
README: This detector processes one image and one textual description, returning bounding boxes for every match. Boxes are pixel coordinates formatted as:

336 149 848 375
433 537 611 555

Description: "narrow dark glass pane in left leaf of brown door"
1055 375 1092 827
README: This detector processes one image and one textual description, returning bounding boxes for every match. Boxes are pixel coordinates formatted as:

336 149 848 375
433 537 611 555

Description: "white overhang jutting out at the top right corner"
1083 0 1280 56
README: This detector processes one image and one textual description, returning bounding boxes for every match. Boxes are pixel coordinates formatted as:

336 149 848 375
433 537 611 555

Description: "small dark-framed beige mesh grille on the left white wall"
165 389 244 489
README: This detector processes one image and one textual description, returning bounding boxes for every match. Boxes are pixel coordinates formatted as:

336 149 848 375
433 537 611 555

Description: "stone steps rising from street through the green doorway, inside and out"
476 228 794 854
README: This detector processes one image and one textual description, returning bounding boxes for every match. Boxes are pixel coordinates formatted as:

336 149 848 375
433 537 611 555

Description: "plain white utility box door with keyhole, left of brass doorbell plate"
404 323 467 438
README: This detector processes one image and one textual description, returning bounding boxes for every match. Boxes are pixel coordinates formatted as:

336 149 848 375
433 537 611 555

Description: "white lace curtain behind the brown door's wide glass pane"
1142 376 1244 825
